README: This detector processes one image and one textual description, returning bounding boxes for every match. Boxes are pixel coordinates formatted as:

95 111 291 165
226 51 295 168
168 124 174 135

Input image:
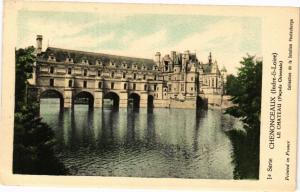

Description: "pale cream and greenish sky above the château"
16 10 262 74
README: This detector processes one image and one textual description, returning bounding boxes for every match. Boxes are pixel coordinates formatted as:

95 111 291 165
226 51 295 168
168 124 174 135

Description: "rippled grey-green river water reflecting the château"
40 99 242 179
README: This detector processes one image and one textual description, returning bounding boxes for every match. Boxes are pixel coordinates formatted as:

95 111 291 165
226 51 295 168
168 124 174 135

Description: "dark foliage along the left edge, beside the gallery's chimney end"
13 47 66 175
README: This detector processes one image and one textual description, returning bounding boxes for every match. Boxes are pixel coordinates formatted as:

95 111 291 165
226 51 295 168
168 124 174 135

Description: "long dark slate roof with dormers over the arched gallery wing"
38 47 155 68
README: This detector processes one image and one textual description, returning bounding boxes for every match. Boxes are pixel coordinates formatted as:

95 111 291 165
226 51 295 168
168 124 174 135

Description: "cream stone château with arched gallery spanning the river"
32 35 226 108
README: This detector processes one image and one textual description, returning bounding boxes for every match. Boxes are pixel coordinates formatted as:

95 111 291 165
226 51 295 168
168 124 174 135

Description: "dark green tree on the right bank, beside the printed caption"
225 55 262 178
